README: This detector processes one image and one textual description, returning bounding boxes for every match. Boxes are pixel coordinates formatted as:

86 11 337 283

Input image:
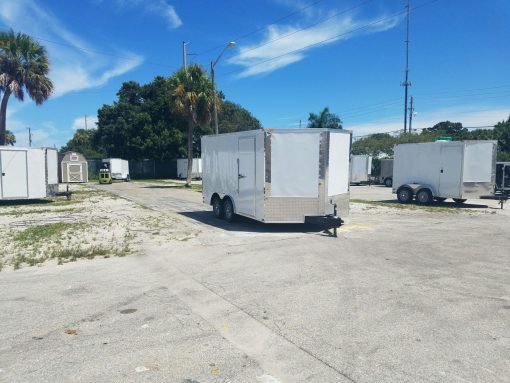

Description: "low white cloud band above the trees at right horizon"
344 105 510 137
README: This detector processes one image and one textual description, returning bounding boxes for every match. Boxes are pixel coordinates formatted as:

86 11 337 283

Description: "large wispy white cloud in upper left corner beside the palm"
0 0 143 97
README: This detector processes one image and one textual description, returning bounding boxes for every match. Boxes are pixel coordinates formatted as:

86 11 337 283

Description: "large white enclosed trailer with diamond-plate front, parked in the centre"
202 129 351 229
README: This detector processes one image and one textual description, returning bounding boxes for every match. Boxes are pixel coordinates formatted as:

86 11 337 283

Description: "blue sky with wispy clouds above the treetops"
0 0 510 147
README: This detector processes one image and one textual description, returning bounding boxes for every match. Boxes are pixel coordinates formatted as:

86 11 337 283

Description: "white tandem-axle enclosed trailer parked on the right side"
393 141 497 204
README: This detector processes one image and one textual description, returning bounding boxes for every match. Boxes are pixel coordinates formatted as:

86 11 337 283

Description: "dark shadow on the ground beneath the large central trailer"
178 210 329 236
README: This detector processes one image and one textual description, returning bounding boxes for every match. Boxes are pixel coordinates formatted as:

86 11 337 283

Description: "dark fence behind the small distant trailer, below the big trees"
87 158 177 180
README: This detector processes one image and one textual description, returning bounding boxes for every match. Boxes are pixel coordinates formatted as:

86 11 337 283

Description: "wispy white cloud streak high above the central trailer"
228 13 401 77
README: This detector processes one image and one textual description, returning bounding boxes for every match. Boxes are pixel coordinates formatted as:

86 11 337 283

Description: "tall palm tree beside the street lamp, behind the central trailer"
169 64 214 186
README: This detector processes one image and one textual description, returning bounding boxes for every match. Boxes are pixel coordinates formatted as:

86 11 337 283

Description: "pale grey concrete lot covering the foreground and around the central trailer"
0 183 510 383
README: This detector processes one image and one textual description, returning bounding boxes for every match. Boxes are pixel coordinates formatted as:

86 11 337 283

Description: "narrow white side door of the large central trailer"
236 137 256 217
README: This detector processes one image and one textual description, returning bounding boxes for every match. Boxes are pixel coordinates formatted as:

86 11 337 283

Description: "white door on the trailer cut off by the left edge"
0 150 28 198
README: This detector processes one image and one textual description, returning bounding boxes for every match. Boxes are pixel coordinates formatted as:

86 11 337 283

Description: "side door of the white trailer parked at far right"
439 145 462 198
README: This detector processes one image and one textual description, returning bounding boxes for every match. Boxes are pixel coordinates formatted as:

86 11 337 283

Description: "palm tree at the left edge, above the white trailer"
0 29 53 145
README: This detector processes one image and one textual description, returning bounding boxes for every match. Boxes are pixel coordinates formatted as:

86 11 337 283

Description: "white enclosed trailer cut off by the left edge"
0 146 58 200
